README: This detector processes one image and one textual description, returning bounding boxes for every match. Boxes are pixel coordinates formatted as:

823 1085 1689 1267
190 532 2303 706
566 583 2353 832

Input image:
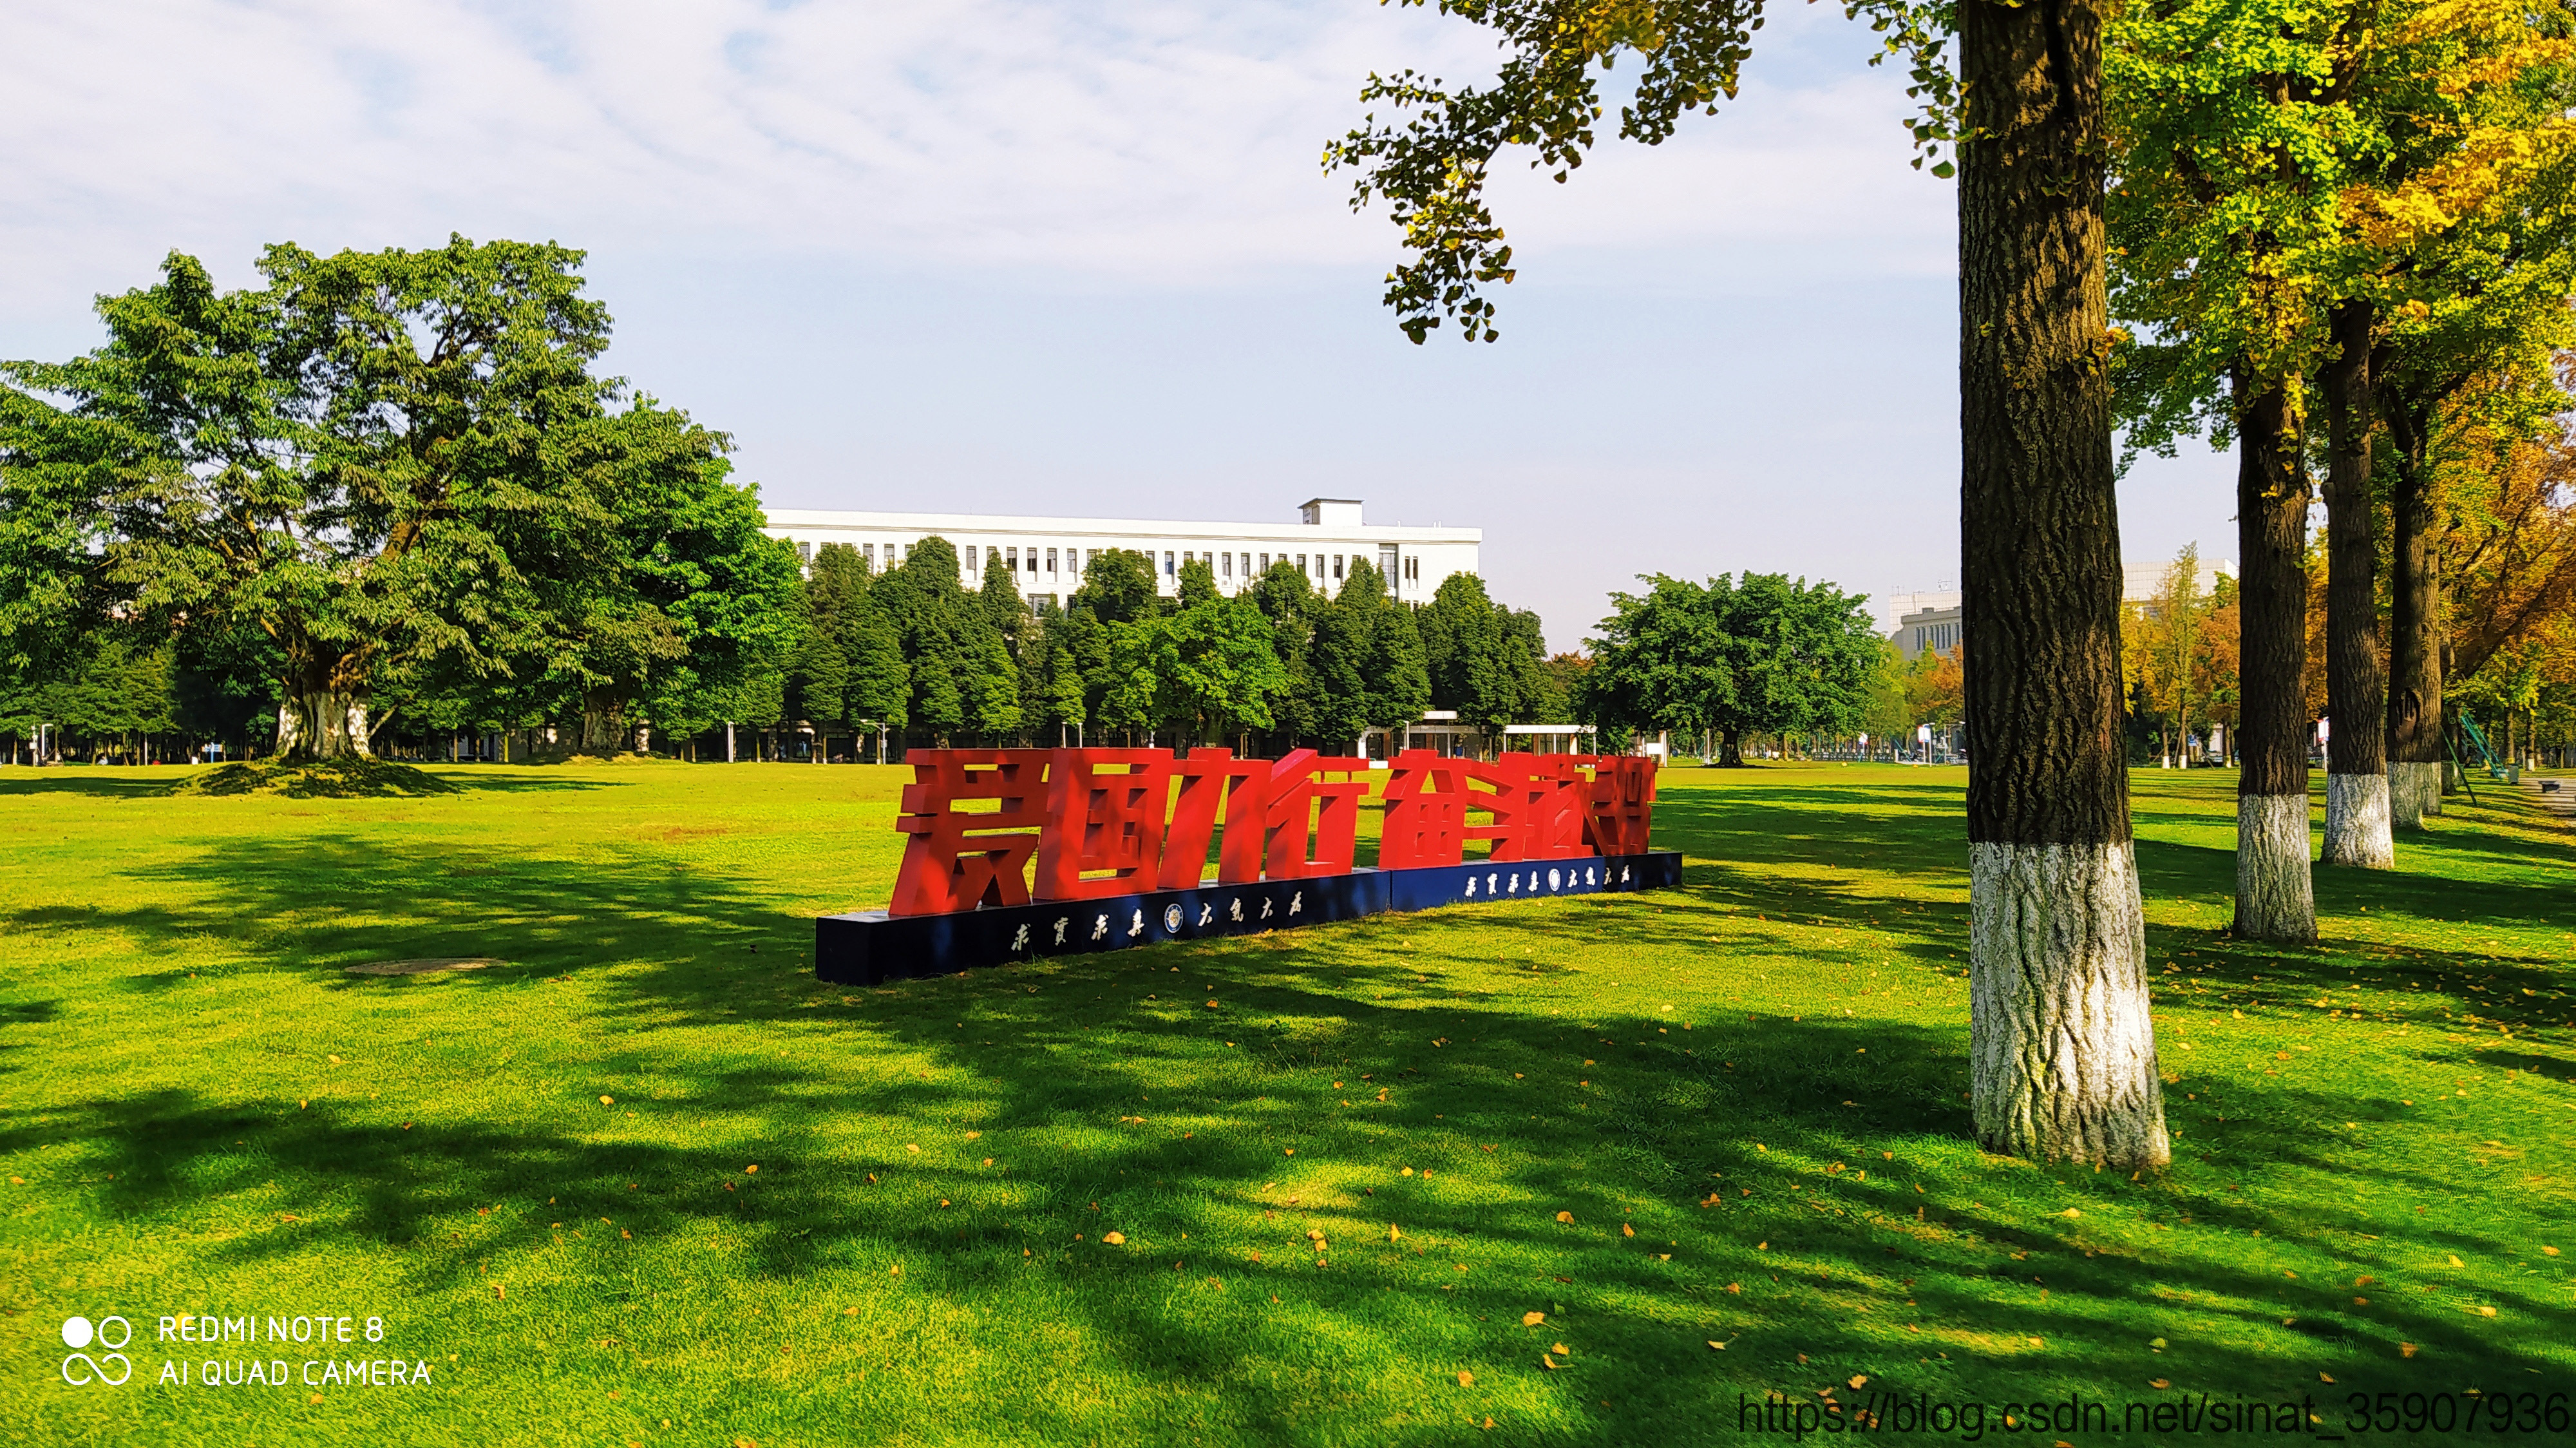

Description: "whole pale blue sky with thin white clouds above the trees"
0 0 2236 647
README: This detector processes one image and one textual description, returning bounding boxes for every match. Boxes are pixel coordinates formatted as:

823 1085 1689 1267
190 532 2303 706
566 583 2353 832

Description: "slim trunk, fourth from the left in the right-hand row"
2385 399 2442 830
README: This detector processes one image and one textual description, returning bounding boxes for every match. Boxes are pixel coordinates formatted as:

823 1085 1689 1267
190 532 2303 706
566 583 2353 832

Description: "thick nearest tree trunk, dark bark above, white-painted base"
1958 0 2172 1170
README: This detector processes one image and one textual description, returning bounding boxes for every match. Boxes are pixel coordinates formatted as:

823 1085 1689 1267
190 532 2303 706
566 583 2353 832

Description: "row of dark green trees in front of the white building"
755 538 1571 750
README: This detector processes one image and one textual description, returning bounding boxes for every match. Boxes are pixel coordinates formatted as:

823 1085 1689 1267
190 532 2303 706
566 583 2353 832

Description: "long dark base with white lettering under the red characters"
814 850 1682 984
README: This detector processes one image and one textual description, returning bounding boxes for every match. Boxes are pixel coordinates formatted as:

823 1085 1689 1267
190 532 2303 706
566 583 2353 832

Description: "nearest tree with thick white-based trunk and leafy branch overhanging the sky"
1324 0 2172 1167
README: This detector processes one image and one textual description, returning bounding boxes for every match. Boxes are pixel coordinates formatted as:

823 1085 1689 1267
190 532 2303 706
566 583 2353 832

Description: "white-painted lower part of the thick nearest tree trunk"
1968 843 2172 1165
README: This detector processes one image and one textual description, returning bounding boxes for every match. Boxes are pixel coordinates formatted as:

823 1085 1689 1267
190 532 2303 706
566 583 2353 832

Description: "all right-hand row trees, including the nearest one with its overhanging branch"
1324 0 2576 1170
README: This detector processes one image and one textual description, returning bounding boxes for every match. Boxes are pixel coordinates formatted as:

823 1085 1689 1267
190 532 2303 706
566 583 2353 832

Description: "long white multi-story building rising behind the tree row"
765 497 1484 605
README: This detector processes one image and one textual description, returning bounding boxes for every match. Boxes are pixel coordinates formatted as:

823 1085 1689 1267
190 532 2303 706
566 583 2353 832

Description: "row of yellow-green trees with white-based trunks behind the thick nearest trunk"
2107 0 2576 940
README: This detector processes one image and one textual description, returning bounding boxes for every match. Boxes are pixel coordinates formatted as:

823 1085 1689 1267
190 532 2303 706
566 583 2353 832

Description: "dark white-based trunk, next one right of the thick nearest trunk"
2233 374 2316 946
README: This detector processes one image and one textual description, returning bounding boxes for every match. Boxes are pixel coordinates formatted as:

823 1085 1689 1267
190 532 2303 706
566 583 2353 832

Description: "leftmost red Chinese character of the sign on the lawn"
886 750 1048 915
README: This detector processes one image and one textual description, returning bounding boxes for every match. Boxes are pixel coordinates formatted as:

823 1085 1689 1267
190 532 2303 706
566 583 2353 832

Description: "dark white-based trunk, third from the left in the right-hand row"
2324 299 2398 871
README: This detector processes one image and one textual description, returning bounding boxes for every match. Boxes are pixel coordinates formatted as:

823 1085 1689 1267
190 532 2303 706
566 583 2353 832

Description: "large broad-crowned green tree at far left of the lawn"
0 237 636 757
